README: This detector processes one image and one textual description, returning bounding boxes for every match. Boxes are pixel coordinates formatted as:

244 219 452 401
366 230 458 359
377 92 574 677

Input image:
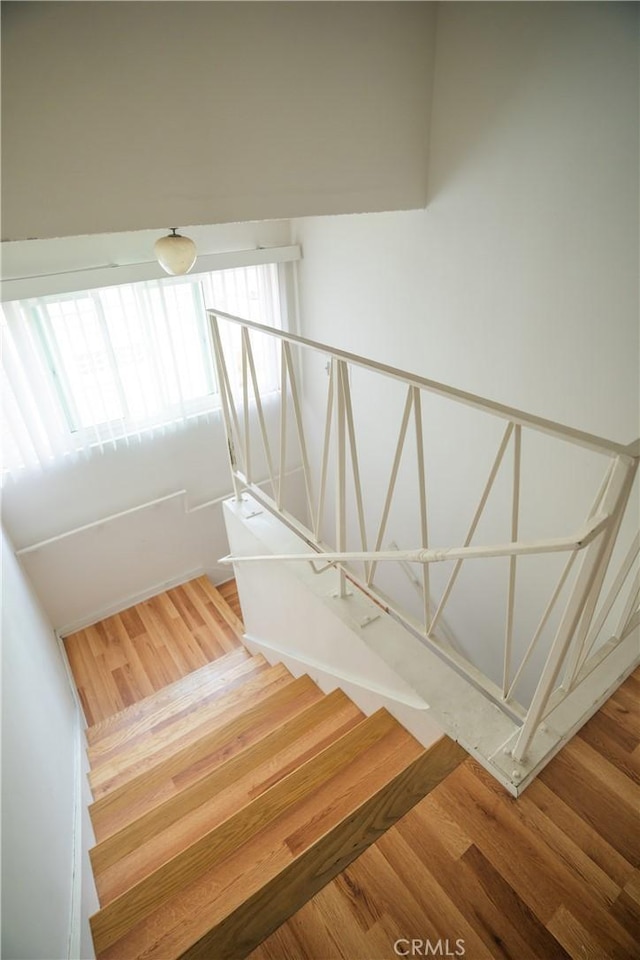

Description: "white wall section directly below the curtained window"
3 390 304 635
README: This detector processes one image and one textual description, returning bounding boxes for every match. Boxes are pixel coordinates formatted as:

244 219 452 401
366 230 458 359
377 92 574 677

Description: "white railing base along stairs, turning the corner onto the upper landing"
224 494 640 796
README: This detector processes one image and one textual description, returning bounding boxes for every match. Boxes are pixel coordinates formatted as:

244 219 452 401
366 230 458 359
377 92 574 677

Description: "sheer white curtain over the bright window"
1 264 281 479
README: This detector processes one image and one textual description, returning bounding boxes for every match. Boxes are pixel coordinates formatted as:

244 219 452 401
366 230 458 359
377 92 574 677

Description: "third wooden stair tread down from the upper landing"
91 690 363 905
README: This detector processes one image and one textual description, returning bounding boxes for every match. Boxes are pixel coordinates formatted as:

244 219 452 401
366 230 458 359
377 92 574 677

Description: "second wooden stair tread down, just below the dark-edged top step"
91 710 422 956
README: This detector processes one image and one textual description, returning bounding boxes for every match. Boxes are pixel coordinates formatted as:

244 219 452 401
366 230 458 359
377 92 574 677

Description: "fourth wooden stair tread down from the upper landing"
89 676 323 841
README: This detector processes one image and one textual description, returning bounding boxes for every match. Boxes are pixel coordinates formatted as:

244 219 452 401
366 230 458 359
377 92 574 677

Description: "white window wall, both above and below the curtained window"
2 221 301 631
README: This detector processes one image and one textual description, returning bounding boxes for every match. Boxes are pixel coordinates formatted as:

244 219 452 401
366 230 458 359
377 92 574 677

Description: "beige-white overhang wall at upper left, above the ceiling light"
2 2 435 240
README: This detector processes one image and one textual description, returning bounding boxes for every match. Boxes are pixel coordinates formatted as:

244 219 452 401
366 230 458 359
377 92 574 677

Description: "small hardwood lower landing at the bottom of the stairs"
64 577 243 725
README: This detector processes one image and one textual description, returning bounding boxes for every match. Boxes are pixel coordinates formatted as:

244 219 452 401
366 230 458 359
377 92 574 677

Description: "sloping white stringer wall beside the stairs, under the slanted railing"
224 495 520 795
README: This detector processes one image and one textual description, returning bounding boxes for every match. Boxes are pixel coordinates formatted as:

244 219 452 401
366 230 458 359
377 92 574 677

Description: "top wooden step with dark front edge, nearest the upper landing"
92 732 464 960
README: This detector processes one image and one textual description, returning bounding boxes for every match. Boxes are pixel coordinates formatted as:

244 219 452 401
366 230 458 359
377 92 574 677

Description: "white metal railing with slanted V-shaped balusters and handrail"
208 310 640 760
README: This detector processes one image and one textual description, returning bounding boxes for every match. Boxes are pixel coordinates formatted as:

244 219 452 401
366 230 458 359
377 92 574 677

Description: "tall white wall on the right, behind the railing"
294 3 640 704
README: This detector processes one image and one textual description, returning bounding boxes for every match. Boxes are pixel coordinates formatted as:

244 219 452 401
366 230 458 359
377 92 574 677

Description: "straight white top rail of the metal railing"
207 307 640 458
